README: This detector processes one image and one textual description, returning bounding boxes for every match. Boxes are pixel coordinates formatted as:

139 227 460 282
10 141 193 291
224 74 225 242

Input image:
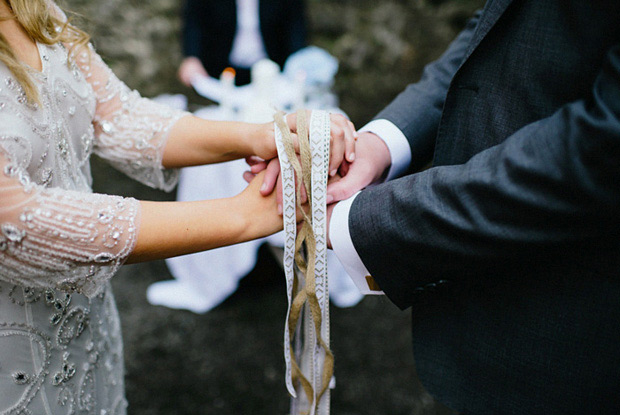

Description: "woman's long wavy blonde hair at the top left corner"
0 0 90 103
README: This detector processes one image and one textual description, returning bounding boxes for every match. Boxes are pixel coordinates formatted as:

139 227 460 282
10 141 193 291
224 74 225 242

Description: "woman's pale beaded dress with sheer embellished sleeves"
0 17 185 415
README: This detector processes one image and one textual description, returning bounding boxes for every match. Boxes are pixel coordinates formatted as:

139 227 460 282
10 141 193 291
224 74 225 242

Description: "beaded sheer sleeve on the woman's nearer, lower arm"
0 146 140 296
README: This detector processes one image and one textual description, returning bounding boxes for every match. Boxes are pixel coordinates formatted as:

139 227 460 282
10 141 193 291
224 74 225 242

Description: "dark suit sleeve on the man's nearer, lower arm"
349 45 620 308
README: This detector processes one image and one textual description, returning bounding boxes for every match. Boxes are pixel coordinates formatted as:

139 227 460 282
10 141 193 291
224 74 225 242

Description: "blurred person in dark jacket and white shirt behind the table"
178 0 306 86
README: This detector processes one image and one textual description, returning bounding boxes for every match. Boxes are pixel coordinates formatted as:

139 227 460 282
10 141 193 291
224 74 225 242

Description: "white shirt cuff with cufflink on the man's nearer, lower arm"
329 192 383 295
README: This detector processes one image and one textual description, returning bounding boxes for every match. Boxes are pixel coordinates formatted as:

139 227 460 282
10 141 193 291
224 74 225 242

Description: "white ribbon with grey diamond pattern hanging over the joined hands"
275 111 331 415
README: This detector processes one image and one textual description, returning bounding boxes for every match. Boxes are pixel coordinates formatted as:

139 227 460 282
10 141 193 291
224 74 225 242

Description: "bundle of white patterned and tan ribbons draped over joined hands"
274 111 334 415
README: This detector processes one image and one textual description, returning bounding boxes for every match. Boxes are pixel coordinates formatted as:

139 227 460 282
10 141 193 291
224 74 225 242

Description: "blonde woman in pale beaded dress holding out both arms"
0 0 354 415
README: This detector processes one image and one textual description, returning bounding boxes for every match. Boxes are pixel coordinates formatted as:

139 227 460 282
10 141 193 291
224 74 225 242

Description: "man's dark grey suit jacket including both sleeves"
349 0 620 415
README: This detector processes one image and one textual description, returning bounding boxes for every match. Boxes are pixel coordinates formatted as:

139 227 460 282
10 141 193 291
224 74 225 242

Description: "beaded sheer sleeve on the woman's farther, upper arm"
75 46 189 191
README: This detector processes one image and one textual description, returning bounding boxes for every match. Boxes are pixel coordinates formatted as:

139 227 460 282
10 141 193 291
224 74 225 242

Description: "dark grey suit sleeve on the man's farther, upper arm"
375 11 481 170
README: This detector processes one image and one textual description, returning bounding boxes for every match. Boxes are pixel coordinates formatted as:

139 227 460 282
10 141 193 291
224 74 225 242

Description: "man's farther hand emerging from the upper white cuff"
327 132 392 203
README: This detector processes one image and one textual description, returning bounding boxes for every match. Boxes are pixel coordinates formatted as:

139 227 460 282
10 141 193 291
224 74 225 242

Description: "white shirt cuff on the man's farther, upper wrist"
359 120 411 180
